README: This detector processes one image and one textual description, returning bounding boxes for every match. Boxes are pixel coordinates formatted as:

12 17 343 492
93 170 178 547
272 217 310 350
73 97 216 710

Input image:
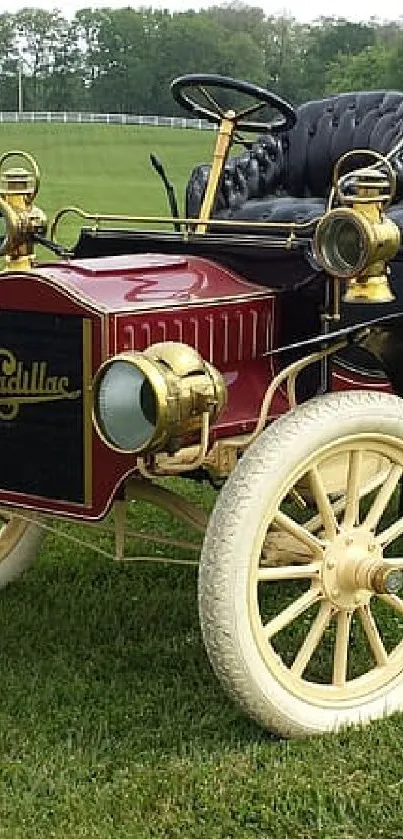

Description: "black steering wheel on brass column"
171 73 297 132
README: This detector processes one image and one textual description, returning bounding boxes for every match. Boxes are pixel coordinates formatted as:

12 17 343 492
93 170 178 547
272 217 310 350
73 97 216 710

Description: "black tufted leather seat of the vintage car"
186 90 403 229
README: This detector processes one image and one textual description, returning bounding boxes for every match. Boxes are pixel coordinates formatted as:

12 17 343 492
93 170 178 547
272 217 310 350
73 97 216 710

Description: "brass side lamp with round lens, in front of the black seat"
314 152 400 303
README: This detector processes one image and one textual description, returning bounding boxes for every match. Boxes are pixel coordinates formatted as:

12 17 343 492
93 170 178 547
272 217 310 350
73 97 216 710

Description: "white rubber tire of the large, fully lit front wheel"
199 391 403 737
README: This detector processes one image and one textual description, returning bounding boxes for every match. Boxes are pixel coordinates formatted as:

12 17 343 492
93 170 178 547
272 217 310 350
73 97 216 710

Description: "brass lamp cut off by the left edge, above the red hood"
0 151 47 271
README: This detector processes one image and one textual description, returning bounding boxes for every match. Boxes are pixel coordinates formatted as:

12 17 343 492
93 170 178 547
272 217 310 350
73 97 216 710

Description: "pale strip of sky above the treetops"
0 0 403 22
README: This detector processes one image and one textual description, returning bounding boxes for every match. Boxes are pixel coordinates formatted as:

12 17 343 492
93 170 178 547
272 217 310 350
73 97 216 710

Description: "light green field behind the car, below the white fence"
0 123 215 246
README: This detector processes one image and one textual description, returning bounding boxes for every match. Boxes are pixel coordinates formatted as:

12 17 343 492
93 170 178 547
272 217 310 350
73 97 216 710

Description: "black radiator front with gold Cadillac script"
0 311 90 504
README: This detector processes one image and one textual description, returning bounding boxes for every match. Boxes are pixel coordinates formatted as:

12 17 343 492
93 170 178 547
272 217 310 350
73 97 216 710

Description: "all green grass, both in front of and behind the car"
0 125 403 839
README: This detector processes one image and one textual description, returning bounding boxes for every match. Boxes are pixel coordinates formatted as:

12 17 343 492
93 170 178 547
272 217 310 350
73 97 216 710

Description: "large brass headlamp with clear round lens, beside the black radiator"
93 341 227 454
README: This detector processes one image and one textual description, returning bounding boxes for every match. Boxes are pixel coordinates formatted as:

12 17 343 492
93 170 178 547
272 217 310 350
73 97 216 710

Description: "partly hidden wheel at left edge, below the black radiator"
0 507 42 589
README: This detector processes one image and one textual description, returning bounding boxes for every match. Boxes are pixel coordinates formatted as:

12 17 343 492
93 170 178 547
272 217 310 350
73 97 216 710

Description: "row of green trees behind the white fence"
4 0 403 115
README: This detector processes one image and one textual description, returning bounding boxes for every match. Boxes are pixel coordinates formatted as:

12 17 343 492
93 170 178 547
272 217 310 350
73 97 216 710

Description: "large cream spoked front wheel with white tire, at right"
199 392 403 736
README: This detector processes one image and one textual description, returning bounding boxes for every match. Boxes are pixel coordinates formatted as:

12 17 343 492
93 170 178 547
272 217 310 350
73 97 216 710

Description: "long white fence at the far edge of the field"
0 111 216 130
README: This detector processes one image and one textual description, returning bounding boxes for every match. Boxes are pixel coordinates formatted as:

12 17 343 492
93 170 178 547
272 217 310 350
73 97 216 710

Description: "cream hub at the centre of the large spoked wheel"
322 526 402 611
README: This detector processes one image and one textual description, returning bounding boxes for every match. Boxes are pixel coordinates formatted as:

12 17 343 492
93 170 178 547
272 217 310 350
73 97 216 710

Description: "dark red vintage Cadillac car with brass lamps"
0 74 403 736
